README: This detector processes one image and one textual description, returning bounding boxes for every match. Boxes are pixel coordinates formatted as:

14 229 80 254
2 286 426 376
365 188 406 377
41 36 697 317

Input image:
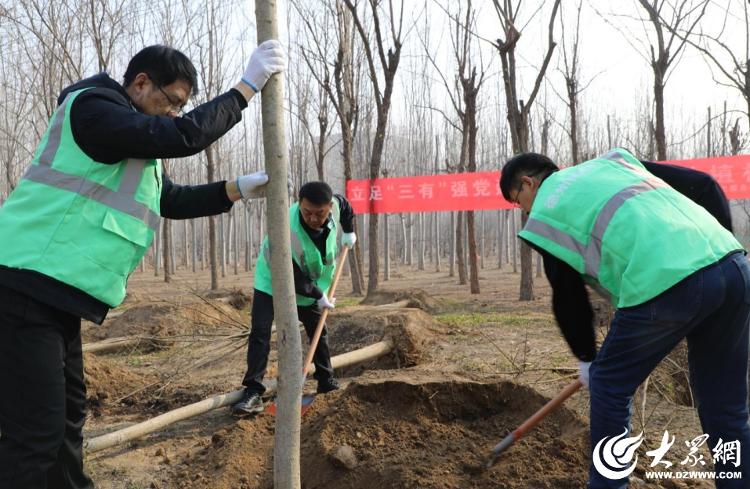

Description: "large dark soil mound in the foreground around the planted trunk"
173 376 588 489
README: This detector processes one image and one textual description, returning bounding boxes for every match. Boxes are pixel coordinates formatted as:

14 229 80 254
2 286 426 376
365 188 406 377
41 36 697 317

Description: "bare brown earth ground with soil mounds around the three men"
84 266 711 489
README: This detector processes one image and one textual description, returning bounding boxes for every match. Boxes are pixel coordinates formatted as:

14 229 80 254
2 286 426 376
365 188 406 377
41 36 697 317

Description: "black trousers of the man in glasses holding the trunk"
0 287 94 489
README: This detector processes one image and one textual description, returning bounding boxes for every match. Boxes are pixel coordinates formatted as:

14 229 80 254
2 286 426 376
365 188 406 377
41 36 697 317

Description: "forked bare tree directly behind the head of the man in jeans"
492 0 560 301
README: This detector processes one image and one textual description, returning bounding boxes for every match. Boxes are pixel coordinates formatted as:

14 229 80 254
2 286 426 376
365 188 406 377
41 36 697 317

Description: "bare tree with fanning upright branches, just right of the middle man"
344 0 404 294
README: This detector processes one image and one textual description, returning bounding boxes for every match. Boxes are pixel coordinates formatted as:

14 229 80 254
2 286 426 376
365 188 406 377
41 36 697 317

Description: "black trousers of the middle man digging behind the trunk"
242 290 333 394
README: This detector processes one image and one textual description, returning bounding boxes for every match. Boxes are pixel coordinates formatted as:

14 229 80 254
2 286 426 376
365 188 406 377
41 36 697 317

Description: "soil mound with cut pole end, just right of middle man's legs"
327 308 445 377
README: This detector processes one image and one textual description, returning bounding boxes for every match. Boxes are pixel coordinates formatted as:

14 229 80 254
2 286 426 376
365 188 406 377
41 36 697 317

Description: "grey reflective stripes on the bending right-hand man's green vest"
524 150 668 279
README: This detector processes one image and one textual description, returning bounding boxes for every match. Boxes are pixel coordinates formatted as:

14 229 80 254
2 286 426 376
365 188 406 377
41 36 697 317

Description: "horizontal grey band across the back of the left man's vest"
23 165 160 231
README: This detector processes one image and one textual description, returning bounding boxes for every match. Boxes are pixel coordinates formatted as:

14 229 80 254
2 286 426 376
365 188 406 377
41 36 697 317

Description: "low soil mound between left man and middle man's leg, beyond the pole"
90 300 247 346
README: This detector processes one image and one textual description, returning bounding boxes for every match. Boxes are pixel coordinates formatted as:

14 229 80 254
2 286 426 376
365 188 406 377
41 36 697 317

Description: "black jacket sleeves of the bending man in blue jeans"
534 161 732 362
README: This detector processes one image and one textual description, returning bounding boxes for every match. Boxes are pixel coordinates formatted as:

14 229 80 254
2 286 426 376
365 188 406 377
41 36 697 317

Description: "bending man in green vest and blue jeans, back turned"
500 148 750 488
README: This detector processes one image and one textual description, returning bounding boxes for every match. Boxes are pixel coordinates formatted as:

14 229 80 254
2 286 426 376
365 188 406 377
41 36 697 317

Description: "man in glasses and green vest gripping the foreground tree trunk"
0 41 285 489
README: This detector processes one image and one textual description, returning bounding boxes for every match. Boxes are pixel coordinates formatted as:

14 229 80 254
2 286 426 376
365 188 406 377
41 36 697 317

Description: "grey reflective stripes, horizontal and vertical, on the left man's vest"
22 95 161 231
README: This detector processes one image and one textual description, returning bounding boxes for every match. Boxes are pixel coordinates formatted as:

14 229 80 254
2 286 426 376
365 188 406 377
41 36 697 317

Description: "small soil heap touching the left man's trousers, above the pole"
83 353 155 416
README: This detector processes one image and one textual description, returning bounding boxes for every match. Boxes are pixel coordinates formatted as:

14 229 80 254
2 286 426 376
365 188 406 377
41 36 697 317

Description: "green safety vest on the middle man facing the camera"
253 198 339 306
